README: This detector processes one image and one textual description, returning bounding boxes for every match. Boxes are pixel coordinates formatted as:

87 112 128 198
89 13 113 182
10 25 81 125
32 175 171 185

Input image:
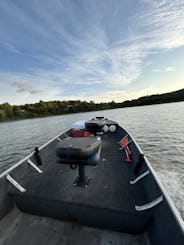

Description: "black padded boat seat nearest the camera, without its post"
56 137 101 166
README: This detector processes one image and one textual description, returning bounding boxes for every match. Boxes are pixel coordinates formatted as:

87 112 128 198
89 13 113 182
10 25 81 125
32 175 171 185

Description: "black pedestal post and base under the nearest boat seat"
73 164 90 188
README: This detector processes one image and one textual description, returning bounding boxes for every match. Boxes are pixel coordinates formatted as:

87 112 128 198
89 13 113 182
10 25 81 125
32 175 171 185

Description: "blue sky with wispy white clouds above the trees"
0 0 184 105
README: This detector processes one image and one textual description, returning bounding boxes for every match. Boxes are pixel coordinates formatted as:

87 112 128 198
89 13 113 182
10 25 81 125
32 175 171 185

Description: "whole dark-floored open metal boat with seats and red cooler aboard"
0 117 184 245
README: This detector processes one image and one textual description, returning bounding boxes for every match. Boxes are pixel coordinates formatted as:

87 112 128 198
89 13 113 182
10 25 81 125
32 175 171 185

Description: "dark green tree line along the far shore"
0 89 184 121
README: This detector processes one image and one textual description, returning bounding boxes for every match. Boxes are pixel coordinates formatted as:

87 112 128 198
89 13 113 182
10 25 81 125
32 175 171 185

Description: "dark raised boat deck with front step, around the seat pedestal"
11 128 150 234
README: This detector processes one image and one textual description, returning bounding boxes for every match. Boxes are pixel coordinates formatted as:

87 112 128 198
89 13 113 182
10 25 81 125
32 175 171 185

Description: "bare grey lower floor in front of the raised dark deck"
0 208 149 245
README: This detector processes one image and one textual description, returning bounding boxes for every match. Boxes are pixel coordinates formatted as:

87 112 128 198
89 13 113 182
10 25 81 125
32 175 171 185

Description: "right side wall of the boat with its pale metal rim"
126 129 184 245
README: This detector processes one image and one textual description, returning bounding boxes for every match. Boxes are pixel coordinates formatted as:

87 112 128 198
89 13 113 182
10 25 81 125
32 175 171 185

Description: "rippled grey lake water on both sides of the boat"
0 102 184 217
